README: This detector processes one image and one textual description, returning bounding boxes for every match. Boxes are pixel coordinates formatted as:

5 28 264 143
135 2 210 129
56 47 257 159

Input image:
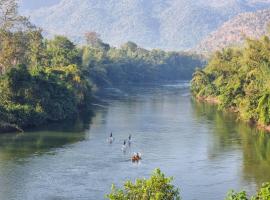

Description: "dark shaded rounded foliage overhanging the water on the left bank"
0 66 91 130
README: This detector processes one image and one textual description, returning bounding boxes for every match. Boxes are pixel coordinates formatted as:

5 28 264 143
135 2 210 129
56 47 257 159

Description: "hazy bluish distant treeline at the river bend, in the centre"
82 33 204 86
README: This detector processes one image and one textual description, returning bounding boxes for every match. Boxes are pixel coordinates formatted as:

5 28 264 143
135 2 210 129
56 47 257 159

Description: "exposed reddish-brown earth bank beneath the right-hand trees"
195 96 270 133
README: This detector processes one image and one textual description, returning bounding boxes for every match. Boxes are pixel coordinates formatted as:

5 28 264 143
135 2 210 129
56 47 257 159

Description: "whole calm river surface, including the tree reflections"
0 82 270 200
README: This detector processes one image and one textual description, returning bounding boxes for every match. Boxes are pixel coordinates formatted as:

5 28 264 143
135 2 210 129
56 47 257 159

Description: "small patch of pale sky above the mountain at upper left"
20 0 60 10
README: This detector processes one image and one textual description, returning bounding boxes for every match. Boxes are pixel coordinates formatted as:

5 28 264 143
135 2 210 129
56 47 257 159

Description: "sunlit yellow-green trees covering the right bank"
191 36 270 129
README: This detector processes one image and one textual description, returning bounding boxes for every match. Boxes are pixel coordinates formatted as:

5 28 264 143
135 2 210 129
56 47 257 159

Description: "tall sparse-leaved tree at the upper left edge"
0 0 37 75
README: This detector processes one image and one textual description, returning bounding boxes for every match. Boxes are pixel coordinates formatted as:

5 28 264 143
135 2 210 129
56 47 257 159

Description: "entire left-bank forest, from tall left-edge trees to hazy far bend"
0 0 202 131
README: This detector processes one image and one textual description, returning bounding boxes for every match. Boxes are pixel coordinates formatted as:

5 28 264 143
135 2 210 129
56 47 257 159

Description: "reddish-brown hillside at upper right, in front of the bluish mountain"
195 9 270 54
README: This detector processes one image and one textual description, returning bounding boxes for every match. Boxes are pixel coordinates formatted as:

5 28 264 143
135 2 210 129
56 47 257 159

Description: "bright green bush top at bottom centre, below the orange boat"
107 169 180 200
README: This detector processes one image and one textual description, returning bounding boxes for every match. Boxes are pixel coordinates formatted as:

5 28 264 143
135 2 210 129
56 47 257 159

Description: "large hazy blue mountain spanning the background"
20 0 270 50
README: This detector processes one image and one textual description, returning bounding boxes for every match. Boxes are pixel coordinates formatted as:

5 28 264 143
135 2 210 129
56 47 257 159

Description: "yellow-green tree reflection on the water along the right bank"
192 99 270 188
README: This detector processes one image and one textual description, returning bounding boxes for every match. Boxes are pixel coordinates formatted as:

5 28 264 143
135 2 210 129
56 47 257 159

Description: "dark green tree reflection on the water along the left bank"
0 116 91 161
